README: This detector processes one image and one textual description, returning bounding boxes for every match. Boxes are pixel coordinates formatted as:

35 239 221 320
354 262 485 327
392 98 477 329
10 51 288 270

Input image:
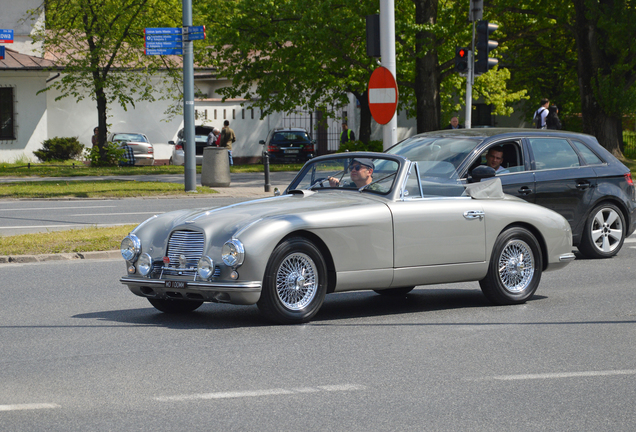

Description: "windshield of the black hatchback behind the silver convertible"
387 136 481 178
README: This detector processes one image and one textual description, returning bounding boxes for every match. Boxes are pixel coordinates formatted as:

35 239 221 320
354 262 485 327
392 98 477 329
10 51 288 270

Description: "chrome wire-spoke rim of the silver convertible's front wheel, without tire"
276 253 318 310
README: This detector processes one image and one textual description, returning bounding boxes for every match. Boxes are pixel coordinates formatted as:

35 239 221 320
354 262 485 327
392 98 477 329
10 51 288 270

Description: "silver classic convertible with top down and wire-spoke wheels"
121 153 574 323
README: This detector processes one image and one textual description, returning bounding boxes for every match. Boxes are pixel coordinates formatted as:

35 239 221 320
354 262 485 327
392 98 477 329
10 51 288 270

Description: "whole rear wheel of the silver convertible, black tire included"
479 227 543 305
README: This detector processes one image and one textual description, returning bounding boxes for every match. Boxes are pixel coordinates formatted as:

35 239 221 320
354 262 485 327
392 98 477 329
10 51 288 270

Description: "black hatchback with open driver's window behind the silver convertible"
387 128 636 258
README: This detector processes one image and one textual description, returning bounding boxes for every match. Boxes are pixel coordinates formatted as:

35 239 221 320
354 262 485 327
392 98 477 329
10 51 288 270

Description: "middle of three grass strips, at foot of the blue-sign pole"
0 180 217 198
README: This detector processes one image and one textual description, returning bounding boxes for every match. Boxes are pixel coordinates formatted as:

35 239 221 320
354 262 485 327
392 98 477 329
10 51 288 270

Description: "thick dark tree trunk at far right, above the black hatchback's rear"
574 0 623 159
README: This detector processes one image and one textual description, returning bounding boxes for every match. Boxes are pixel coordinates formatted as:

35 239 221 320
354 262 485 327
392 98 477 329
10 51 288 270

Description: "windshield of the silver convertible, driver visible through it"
289 153 400 194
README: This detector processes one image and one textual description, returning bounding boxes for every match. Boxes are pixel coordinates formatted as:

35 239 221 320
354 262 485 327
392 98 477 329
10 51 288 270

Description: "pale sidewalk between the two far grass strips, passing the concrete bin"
0 171 296 198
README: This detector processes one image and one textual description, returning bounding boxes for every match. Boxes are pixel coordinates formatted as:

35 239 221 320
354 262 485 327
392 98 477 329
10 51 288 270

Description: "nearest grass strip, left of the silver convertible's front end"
0 224 137 255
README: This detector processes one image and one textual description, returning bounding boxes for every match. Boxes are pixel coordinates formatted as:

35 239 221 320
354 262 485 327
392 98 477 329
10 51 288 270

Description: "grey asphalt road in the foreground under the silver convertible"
0 243 636 432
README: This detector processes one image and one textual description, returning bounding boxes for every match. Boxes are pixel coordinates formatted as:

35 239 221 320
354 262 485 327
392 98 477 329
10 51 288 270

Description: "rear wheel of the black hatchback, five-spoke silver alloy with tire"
579 203 626 258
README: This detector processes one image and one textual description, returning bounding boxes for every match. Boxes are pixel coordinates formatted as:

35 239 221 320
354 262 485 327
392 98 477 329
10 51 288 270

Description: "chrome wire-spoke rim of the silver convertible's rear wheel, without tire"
498 240 534 293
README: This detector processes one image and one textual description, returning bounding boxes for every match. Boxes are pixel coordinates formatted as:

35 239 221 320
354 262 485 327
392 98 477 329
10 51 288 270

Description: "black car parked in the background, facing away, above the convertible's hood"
259 128 316 163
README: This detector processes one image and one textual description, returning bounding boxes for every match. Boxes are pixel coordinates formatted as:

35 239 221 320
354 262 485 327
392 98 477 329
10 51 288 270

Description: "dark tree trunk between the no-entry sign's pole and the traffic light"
414 0 442 133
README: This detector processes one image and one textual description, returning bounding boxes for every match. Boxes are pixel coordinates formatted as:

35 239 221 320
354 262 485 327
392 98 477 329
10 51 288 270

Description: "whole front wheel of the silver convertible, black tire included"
257 237 327 324
